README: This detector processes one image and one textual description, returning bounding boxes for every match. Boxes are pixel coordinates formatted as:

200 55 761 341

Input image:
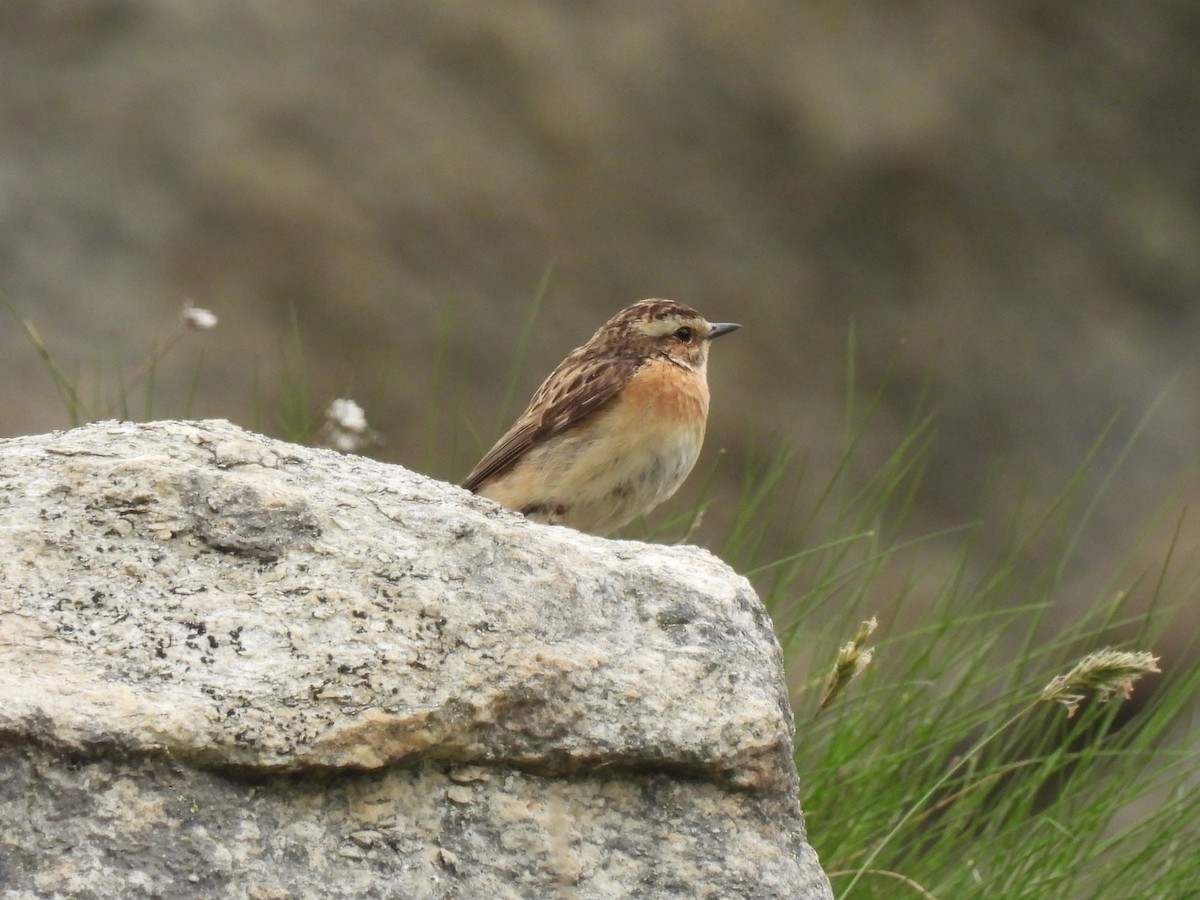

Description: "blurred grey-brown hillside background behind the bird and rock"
0 0 1200 653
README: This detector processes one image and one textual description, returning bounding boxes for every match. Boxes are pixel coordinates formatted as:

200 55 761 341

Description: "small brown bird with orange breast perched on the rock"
462 298 740 535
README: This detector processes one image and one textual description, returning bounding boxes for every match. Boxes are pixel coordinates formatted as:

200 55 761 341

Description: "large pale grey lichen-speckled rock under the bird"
0 421 830 898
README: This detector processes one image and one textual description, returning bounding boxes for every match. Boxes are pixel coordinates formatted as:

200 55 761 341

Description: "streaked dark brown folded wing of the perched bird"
462 348 644 491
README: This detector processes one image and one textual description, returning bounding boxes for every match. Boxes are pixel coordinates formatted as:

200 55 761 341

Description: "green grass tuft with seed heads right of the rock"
700 388 1200 900
